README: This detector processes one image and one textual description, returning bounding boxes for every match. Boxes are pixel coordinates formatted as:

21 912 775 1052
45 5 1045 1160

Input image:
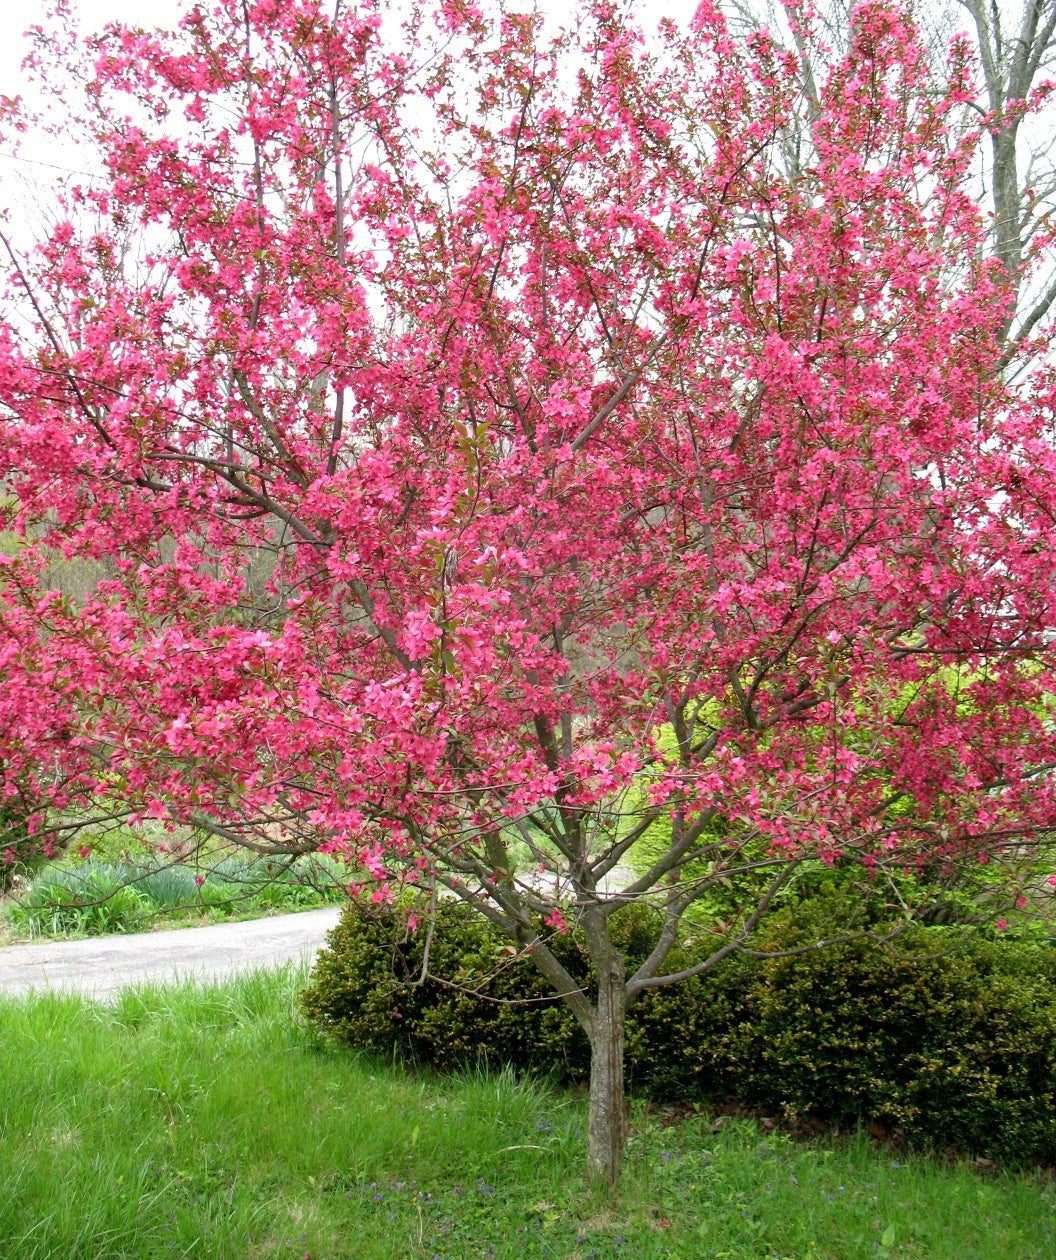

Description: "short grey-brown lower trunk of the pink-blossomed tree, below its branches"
587 931 626 1186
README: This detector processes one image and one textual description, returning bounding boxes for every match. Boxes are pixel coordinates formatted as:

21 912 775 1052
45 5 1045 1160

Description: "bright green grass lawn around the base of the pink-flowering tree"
0 970 1056 1260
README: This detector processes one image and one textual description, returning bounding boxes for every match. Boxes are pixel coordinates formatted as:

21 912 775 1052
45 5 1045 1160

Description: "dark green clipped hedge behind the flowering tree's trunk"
296 903 1056 1164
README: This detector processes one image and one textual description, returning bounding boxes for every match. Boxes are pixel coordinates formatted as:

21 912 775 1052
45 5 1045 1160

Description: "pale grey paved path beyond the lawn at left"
0 906 340 997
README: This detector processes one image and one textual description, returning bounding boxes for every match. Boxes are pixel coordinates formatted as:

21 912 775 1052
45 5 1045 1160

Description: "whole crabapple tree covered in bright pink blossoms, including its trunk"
0 0 1056 1181
